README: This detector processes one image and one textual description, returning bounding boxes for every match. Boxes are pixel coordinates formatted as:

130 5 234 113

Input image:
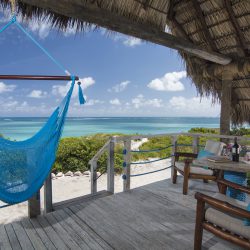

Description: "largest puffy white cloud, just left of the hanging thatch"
147 71 187 91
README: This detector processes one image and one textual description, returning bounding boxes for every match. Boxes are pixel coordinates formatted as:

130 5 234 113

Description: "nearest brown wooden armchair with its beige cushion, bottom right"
194 180 250 250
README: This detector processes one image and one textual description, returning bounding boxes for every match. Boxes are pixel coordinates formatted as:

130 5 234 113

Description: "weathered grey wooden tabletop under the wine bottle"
193 158 250 173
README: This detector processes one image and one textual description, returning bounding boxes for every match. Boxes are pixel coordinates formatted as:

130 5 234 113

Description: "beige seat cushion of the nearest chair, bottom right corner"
205 208 250 240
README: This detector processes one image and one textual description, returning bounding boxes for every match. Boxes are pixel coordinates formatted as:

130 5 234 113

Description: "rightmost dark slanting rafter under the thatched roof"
224 0 249 55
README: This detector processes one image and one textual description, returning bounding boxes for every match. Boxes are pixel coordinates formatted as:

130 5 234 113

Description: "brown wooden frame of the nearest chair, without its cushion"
194 180 250 250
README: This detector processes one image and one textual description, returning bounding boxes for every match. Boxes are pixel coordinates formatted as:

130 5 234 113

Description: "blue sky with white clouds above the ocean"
0 11 220 117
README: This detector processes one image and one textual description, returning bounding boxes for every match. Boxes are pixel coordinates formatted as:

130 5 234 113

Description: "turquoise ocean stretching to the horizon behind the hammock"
0 117 219 141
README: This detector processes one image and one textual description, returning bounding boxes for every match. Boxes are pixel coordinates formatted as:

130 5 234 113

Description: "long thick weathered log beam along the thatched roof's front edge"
21 0 232 65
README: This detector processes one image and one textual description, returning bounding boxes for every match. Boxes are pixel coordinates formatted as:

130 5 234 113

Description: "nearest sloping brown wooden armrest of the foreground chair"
194 192 250 219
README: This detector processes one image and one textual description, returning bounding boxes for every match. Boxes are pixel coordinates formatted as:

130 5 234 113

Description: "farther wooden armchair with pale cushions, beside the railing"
172 140 225 195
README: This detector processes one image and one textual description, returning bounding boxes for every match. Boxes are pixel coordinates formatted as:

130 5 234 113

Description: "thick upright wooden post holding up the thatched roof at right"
220 71 233 143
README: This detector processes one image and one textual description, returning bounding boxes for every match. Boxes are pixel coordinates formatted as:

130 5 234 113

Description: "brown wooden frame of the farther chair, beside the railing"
172 152 217 195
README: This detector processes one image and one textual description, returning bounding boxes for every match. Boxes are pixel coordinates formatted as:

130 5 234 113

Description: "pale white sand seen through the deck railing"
0 159 171 224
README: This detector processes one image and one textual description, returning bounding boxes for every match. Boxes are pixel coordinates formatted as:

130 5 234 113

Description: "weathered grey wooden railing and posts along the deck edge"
29 133 250 217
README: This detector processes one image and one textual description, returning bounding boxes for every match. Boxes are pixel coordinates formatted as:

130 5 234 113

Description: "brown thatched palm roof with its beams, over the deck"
0 0 250 124
